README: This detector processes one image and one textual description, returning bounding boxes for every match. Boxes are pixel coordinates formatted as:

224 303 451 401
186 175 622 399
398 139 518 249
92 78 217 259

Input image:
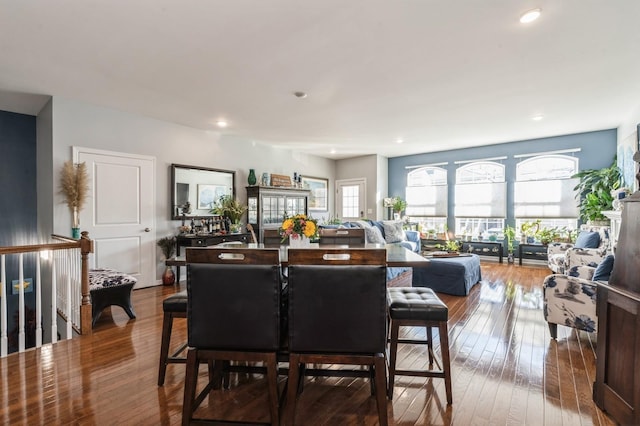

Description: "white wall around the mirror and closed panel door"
38 97 335 277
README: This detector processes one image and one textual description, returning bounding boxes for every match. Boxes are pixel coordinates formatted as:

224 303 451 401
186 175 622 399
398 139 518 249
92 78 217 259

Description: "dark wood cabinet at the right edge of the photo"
593 192 640 424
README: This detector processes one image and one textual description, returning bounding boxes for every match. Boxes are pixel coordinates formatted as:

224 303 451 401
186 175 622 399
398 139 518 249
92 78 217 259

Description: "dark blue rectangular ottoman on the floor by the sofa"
412 254 482 296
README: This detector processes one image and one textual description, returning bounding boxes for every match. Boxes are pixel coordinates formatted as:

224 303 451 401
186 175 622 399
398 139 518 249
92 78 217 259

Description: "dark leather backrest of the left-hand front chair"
186 248 281 351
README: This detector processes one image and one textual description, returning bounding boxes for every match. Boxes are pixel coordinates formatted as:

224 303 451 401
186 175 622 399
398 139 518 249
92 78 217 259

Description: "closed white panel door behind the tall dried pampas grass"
73 147 156 288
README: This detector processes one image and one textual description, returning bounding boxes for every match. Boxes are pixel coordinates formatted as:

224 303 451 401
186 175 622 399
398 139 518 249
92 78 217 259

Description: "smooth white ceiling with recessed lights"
0 0 640 158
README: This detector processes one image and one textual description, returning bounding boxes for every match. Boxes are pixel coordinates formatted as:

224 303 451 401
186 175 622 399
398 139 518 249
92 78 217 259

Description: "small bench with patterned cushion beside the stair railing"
89 269 138 327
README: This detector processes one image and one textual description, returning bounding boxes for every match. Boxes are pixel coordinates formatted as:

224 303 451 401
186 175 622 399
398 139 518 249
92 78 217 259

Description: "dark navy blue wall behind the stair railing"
0 111 38 352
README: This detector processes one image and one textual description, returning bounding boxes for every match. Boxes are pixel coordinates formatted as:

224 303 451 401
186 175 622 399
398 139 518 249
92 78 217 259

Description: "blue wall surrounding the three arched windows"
389 129 618 229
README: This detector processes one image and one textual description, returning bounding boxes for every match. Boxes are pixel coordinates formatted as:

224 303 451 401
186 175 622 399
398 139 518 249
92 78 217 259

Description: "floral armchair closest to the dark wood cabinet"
542 265 598 339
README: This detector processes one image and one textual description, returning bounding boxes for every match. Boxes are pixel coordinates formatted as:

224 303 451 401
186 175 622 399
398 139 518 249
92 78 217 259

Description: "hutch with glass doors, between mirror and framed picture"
247 186 310 242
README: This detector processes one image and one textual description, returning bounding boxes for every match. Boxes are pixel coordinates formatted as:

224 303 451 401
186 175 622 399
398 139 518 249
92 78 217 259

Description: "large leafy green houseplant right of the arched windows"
572 157 624 222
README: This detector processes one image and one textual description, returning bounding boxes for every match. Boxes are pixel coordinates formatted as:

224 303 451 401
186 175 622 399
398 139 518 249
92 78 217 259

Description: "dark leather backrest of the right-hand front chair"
288 248 387 354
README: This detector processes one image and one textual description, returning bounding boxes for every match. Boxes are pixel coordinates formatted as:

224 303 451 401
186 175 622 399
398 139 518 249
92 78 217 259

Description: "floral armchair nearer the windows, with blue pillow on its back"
547 225 611 274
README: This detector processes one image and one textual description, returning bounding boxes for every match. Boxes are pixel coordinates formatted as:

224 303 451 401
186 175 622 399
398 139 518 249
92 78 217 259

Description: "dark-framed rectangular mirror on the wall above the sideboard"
171 164 236 220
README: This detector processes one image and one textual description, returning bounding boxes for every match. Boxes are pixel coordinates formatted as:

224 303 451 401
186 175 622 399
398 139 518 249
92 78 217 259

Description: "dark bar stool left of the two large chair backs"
158 290 187 386
